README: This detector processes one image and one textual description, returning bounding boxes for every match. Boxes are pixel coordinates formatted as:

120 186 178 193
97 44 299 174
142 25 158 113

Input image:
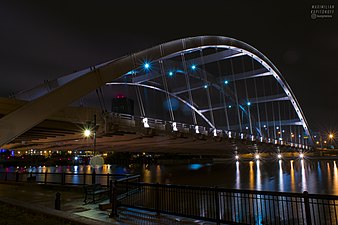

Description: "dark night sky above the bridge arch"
0 0 338 130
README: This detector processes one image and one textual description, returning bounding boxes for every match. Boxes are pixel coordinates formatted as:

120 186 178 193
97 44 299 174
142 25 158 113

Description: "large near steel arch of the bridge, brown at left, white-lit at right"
0 36 311 145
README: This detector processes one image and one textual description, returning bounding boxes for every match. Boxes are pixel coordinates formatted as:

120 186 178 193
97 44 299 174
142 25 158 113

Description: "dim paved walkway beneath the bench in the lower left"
0 182 214 225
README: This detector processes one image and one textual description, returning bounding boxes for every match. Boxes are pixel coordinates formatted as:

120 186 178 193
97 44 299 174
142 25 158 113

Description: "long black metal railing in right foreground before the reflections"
114 180 338 225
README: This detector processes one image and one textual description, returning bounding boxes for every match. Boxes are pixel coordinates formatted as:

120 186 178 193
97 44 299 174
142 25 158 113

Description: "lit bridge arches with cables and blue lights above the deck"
0 36 313 151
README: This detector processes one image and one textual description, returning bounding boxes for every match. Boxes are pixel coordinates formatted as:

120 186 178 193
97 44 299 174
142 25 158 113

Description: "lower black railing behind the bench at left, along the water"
0 171 140 187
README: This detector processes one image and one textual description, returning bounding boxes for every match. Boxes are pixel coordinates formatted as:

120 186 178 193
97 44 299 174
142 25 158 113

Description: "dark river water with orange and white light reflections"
2 159 338 195
